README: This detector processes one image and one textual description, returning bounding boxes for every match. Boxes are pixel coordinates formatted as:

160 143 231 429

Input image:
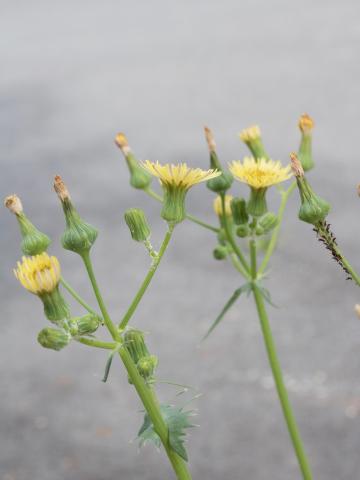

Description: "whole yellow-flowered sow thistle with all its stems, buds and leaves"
5 114 360 480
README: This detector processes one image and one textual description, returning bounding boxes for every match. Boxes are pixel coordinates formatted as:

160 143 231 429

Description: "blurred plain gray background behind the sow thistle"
0 0 360 480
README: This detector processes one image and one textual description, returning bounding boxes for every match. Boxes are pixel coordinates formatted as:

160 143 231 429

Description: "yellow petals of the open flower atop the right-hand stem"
229 157 292 188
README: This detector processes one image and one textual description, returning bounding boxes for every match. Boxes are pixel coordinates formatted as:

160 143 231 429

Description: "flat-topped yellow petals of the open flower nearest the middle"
142 160 221 190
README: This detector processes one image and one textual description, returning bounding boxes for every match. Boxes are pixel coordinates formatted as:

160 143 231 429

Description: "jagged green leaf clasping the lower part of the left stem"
138 405 194 461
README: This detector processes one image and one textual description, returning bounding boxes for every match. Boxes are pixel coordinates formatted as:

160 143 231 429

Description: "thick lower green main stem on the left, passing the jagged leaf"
119 348 191 480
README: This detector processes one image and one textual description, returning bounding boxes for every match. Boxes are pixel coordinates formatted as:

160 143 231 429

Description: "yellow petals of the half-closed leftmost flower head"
14 252 60 295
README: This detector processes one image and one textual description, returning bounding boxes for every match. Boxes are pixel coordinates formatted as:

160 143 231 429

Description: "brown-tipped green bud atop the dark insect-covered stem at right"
290 153 330 225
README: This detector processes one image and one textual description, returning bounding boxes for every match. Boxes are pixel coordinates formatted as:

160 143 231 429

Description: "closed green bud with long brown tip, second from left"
54 175 98 255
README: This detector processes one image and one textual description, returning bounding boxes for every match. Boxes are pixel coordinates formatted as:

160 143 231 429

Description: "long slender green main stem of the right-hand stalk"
250 244 312 480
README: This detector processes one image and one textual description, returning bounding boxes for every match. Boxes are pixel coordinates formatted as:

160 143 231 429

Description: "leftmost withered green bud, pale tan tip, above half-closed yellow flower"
4 195 51 255
